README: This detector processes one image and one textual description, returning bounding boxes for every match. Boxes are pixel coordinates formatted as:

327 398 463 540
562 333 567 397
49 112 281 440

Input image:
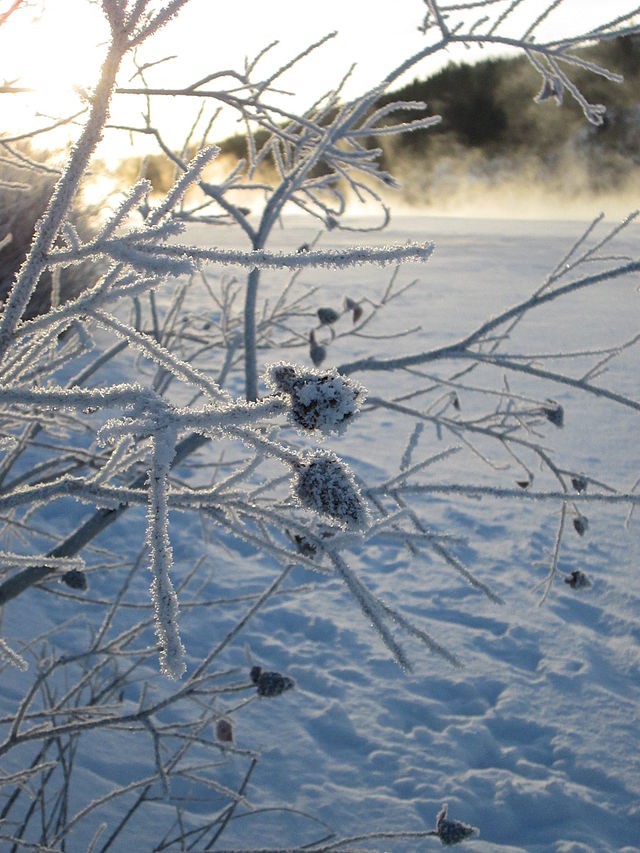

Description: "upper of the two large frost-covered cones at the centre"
267 363 366 435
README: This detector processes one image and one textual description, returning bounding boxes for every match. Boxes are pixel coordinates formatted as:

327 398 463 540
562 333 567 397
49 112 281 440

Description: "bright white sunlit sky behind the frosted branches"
0 0 635 158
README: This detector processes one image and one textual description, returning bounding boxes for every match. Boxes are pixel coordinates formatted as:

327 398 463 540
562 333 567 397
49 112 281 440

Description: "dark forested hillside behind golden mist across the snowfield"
132 37 640 209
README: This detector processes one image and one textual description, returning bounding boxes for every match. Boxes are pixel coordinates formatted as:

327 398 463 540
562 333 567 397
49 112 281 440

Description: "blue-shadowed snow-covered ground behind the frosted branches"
4 217 640 853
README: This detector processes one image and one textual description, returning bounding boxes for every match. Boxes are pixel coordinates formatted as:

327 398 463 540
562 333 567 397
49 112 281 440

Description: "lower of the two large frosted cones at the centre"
292 451 369 530
